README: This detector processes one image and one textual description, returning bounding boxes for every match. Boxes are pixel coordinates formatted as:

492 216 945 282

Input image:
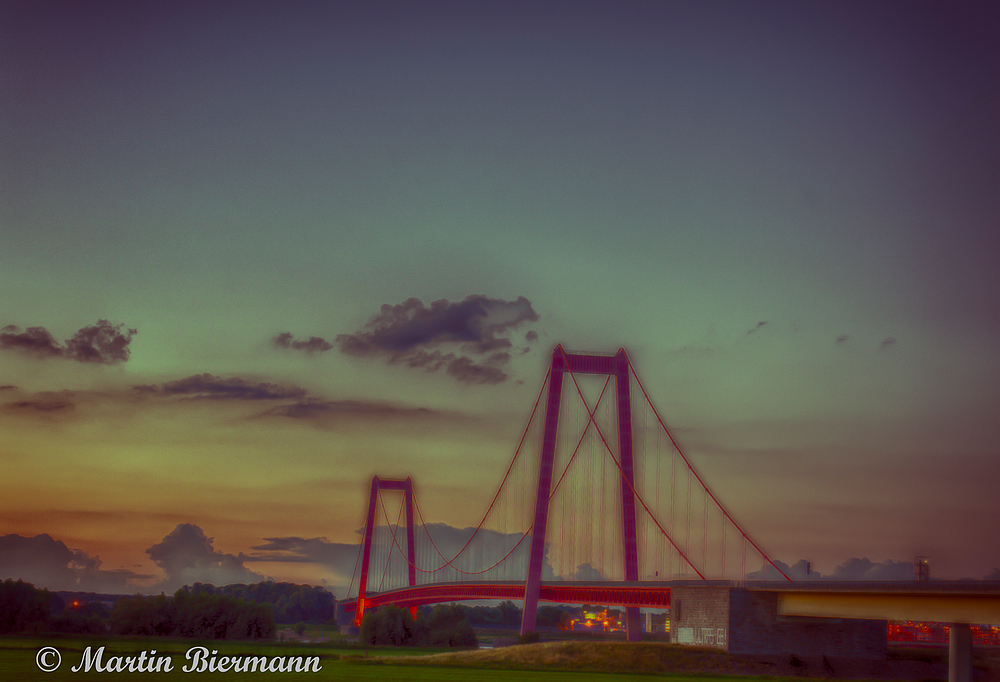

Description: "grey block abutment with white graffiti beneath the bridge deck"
670 585 887 659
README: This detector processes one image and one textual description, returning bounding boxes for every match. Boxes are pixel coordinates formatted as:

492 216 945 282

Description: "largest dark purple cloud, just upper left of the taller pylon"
336 296 538 384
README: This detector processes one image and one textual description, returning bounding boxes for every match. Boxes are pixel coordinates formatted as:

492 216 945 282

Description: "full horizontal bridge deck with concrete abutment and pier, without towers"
341 580 1000 682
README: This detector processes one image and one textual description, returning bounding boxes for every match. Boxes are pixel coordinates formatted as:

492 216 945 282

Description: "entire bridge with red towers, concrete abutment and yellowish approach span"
341 346 1000 682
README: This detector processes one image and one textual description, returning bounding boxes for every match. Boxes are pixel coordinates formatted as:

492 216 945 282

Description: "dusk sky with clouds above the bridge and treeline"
0 0 1000 592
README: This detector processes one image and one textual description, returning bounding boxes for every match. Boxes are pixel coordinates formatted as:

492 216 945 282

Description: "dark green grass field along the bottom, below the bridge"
0 637 976 682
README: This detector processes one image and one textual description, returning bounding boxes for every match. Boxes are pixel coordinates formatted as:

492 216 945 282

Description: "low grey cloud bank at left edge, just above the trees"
0 533 152 593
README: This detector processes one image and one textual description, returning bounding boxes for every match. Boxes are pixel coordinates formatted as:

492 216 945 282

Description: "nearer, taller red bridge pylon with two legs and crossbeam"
521 345 640 642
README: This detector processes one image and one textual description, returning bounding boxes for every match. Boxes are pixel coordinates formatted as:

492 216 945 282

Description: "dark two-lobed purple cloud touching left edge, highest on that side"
0 320 138 365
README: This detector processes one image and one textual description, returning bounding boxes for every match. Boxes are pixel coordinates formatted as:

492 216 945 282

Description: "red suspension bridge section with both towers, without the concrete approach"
345 346 788 640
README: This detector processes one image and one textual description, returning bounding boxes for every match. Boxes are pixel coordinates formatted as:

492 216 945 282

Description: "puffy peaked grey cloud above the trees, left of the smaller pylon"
146 523 265 589
